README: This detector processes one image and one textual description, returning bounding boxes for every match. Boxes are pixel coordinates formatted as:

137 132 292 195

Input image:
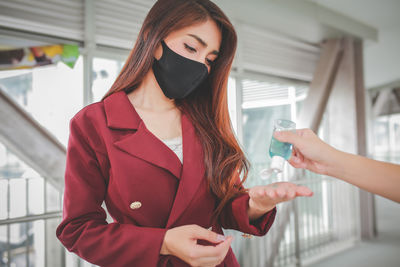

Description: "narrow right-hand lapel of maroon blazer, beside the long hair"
166 114 205 228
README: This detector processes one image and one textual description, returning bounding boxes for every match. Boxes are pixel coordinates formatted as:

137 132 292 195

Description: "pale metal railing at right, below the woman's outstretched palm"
227 166 360 267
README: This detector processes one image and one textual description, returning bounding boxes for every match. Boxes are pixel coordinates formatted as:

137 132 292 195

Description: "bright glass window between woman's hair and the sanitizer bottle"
236 79 308 186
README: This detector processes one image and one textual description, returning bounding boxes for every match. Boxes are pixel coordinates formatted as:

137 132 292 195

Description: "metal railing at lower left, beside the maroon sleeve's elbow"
0 177 62 267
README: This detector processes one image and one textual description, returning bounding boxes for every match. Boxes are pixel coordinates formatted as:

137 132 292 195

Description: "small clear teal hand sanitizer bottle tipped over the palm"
260 119 296 179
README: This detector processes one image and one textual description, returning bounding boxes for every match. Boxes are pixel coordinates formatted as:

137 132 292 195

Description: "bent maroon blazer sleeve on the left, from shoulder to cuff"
56 118 166 266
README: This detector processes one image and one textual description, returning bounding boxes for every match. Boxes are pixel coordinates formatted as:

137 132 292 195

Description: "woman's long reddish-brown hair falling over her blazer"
102 0 249 222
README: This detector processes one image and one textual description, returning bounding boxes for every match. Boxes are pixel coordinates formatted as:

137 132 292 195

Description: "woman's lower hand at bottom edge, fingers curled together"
160 224 233 267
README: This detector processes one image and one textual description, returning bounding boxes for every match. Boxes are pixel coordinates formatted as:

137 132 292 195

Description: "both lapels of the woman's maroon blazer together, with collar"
104 91 209 228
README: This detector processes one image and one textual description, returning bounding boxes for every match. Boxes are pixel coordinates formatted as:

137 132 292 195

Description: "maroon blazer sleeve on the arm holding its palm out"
219 182 276 236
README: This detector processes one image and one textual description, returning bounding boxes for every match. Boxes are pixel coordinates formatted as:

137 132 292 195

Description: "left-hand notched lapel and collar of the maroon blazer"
104 91 183 178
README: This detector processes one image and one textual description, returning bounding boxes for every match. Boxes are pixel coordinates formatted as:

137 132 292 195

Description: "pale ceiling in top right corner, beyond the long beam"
309 0 400 88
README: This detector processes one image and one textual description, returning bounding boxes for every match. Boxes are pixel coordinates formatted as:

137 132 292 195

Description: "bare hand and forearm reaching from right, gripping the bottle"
274 129 400 202
